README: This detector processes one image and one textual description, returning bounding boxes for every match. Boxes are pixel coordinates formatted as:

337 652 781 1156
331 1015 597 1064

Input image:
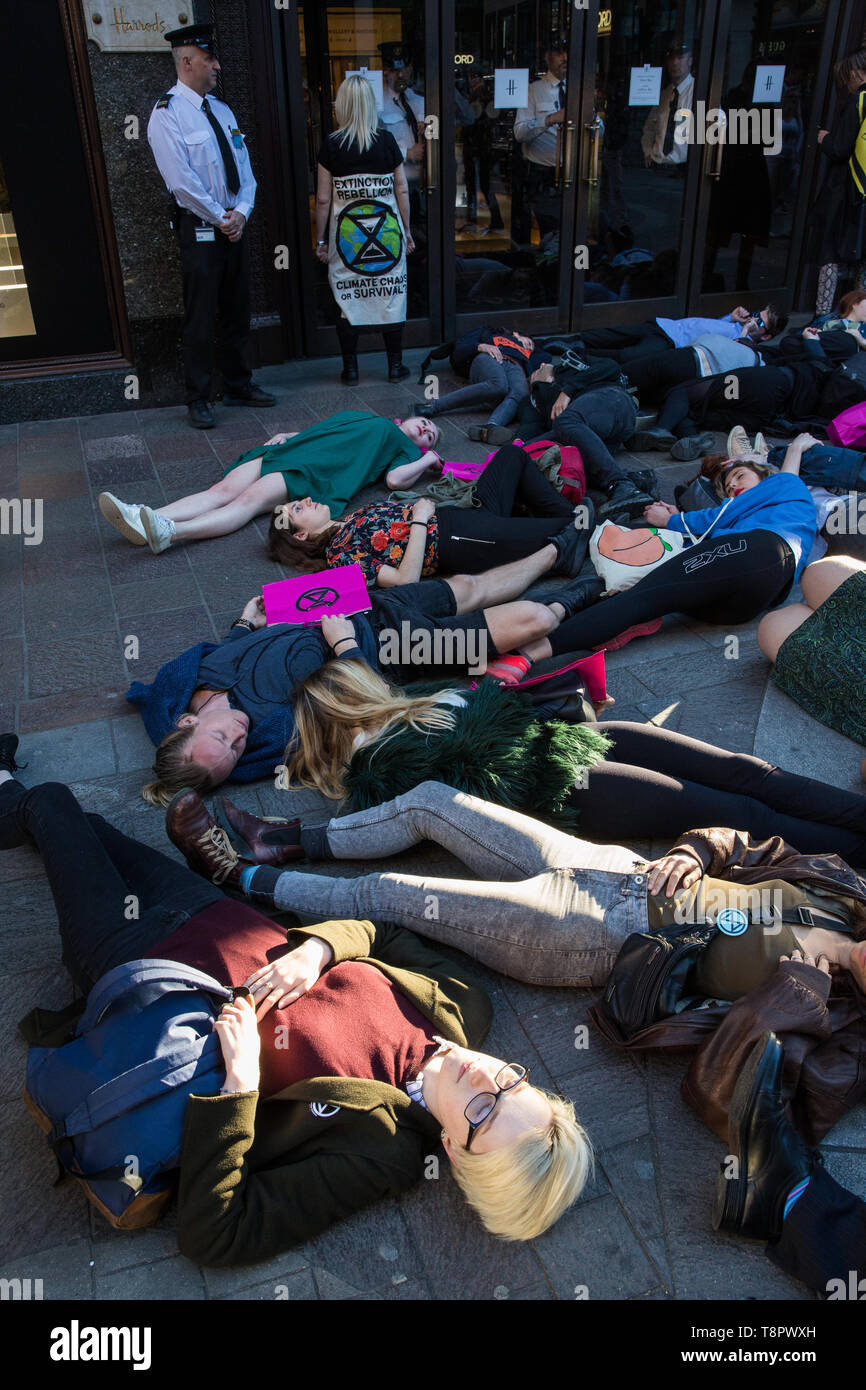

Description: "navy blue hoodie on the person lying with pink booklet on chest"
126 613 378 781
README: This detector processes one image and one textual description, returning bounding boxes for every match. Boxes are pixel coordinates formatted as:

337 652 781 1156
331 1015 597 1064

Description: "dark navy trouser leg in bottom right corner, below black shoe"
766 1168 866 1298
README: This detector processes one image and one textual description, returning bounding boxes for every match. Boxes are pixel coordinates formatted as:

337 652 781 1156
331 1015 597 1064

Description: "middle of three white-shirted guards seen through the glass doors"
514 38 569 240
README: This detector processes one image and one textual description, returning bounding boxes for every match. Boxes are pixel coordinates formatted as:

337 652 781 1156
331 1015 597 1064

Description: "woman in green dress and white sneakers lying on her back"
99 410 441 555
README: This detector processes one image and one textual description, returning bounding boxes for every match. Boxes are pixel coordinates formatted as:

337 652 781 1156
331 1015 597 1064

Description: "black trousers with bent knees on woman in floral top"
436 443 574 574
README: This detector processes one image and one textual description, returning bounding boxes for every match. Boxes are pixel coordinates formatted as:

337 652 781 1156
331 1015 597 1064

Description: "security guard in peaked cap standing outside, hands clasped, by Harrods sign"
147 24 275 430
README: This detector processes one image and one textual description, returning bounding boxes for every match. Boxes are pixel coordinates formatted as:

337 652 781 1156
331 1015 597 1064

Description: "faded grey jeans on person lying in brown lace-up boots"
274 781 648 987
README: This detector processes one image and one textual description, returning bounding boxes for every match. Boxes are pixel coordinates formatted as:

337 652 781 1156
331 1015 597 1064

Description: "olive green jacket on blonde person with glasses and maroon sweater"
178 922 492 1265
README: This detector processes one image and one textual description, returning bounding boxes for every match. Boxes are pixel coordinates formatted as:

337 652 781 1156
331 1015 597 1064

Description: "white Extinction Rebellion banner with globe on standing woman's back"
328 174 406 327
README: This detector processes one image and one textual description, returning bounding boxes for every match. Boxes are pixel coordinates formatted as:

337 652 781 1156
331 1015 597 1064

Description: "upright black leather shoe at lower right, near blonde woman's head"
713 1033 817 1241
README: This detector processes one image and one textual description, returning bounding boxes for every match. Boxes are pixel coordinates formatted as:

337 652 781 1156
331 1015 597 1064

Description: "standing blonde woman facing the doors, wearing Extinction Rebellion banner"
316 75 414 385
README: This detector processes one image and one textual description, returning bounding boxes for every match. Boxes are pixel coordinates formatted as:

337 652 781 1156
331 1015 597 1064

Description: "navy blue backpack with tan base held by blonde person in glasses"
24 960 242 1230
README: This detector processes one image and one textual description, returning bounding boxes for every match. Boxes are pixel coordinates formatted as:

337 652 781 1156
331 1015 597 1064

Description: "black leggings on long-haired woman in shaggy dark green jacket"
571 721 866 865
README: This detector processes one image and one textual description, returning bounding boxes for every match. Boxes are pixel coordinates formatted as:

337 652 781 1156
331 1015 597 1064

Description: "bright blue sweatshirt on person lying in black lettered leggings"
664 473 817 582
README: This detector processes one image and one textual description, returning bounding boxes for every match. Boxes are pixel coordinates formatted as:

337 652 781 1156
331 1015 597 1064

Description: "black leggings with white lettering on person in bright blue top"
549 531 796 656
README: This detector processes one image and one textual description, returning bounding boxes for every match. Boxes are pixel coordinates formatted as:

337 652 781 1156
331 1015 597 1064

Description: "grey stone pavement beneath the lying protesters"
0 353 866 1300
